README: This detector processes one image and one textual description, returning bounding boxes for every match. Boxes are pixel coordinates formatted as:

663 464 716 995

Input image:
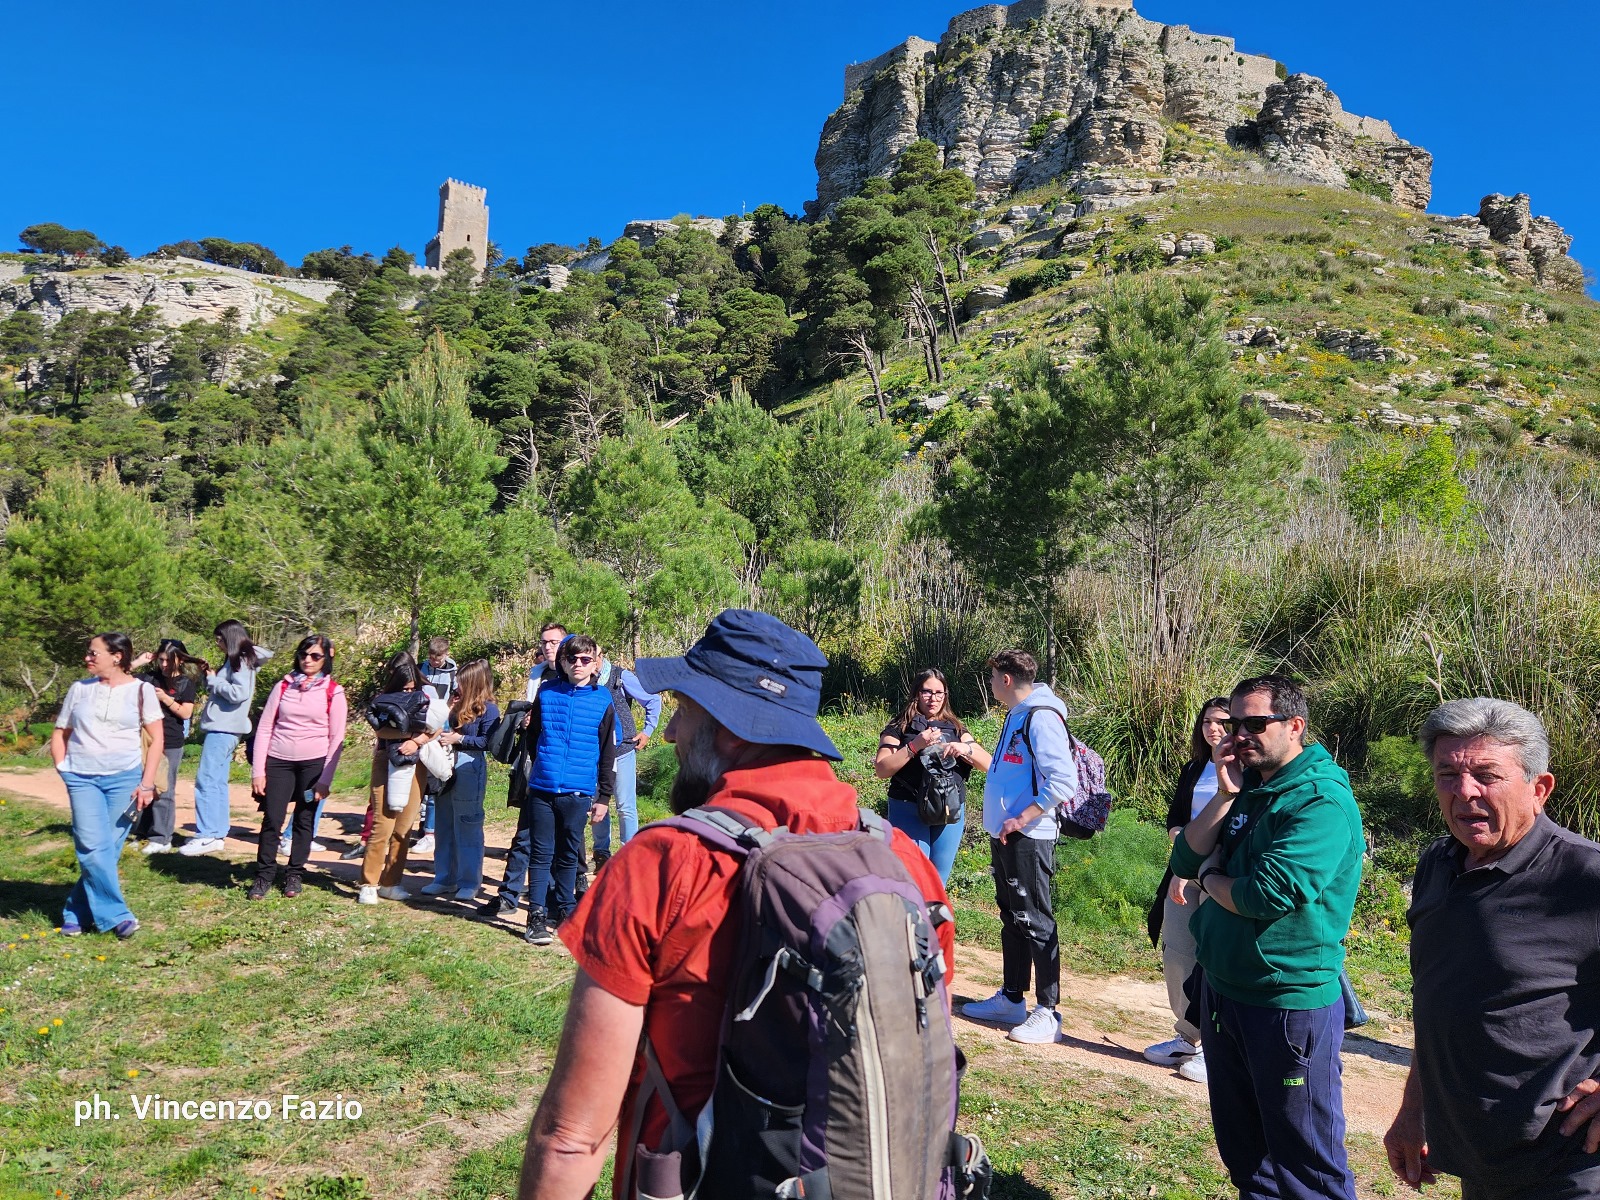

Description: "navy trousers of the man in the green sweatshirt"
1200 982 1355 1200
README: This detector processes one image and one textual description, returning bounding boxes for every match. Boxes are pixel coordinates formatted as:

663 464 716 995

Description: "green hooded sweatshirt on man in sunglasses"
1171 746 1365 1010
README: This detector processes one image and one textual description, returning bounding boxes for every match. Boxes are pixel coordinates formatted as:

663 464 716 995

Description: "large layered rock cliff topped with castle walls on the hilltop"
808 0 1434 213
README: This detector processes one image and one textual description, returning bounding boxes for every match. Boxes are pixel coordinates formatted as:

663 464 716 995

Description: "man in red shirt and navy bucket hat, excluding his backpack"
518 610 955 1200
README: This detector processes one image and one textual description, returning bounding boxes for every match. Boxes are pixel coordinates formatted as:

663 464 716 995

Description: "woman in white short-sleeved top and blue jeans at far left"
50 634 162 939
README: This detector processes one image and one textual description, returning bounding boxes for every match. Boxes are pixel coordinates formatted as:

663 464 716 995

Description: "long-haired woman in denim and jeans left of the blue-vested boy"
422 658 499 901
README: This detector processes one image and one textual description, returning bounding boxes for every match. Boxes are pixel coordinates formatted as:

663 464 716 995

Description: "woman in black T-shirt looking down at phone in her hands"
872 667 989 883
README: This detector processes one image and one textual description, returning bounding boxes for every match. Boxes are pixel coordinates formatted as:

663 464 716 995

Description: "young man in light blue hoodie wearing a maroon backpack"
962 650 1078 1045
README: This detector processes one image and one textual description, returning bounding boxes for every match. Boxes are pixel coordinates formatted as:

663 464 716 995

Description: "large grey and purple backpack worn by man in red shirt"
619 806 989 1200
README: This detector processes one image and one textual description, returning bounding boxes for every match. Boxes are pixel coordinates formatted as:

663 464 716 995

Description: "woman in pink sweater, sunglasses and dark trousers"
250 634 349 899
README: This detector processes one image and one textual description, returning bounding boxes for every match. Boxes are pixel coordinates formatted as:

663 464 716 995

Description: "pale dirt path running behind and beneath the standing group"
0 771 1411 1136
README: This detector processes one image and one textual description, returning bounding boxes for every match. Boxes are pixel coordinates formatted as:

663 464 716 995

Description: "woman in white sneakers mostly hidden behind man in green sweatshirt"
1144 696 1227 1083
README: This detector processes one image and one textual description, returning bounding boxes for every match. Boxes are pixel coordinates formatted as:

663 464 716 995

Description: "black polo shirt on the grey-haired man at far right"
1406 813 1600 1190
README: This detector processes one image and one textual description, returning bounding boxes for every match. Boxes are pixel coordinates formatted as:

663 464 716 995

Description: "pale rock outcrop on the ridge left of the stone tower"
0 259 338 331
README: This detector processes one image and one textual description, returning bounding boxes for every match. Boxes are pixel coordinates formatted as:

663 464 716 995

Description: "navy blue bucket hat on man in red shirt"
634 608 843 762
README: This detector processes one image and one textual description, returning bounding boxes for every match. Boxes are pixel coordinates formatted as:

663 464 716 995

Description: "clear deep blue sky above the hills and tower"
0 0 1600 291
